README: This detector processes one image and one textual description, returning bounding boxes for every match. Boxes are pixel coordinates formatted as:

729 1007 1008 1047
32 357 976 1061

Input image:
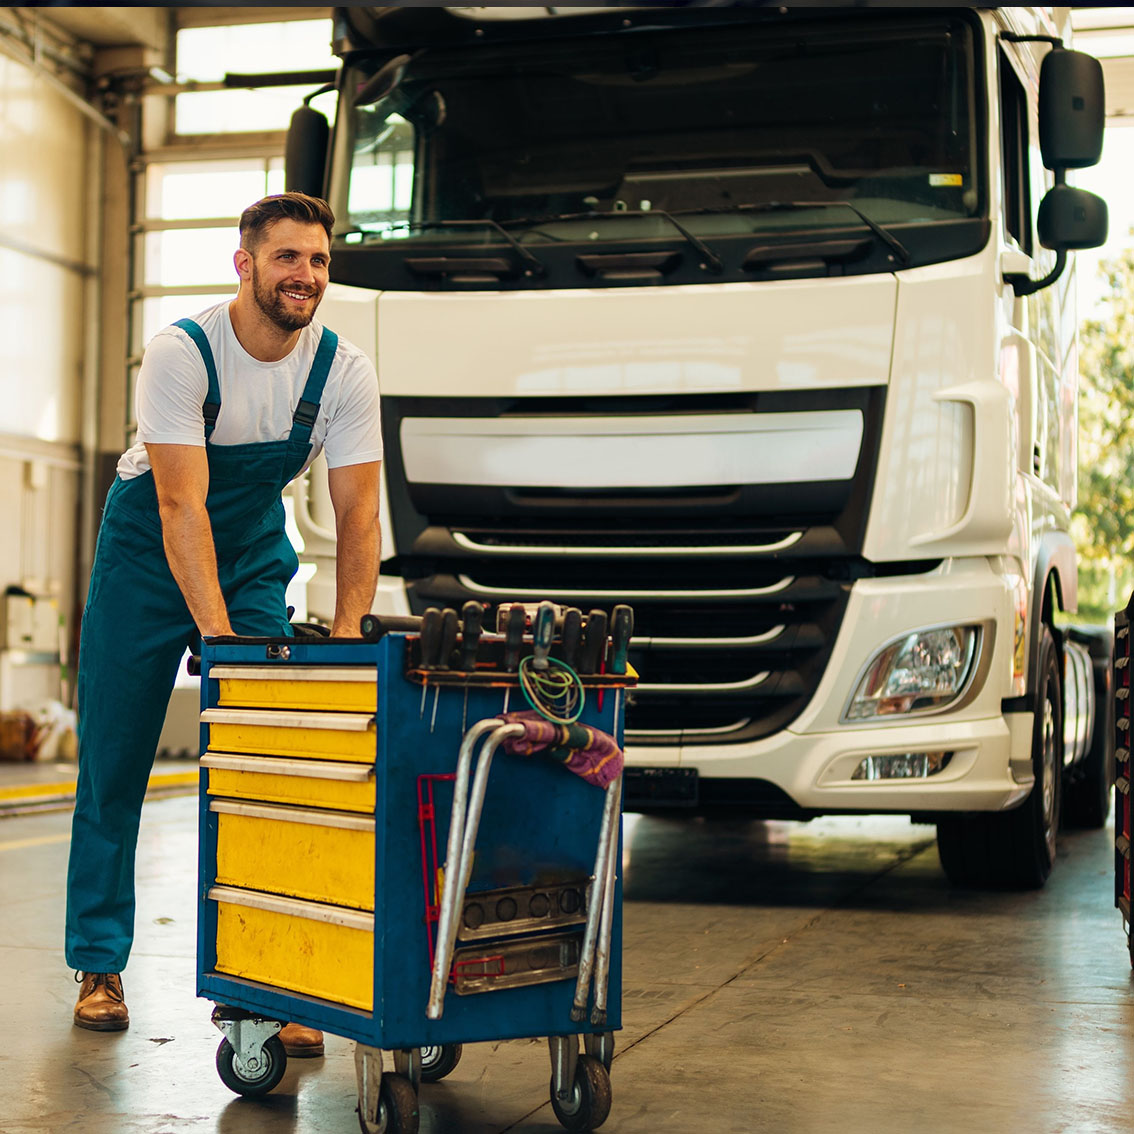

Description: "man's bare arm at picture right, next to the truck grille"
328 460 382 637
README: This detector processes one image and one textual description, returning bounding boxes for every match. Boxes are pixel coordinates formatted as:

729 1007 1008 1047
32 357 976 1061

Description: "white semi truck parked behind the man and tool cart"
288 6 1111 887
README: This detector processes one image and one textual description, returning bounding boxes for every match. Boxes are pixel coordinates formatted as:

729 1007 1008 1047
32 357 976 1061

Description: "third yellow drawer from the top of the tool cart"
201 752 374 815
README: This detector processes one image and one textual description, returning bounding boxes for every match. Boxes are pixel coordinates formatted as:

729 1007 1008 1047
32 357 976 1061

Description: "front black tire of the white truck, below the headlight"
937 626 1063 890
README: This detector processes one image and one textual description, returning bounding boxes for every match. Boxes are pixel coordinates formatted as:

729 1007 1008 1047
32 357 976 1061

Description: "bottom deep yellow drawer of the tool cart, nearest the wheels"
209 886 374 1012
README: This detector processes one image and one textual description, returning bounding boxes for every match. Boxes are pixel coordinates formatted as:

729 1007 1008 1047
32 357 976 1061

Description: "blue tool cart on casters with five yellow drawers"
197 603 635 1134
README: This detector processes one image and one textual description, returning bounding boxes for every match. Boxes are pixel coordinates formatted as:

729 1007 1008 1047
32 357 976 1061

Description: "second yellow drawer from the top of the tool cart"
201 709 378 764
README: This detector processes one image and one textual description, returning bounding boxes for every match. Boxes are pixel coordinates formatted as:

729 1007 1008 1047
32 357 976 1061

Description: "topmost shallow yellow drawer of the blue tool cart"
209 665 378 713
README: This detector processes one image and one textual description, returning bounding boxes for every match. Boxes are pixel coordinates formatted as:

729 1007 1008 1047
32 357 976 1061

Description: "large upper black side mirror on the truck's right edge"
1039 48 1107 170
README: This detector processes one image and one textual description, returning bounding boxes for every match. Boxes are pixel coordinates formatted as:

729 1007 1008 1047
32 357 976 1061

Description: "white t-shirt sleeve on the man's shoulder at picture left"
134 329 209 446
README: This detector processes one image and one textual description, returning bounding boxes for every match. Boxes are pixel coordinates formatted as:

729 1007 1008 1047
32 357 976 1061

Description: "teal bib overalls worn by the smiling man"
66 319 338 973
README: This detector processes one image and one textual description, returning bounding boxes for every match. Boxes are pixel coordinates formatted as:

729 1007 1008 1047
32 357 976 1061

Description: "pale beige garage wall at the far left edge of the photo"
0 46 98 709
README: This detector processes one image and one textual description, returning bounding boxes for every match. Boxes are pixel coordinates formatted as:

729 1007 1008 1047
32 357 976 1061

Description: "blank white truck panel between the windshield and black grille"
371 276 897 398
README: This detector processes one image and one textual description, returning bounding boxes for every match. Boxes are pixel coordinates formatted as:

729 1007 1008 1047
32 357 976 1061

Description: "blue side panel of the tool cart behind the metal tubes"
374 635 621 1047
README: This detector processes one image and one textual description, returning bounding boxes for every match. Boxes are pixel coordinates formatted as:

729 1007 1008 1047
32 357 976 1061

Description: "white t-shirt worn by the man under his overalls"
118 301 382 481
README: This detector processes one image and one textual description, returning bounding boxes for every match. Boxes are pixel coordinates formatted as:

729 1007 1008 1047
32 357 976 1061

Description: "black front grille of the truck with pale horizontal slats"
383 390 881 746
